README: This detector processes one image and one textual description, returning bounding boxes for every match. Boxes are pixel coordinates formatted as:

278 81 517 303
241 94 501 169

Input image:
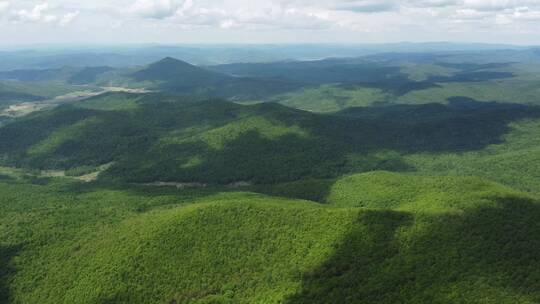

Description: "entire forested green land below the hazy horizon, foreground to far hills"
0 49 540 304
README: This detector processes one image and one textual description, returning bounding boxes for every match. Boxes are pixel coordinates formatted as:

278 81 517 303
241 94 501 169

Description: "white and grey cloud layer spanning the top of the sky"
0 0 540 41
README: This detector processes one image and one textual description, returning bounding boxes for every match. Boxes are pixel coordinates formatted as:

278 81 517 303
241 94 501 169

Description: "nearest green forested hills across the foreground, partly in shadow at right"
0 172 540 303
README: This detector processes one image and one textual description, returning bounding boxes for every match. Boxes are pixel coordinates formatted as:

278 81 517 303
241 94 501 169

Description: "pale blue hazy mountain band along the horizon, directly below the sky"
0 42 527 71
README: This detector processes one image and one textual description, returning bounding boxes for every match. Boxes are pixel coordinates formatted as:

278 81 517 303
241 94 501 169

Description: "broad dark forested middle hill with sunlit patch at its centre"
0 93 540 188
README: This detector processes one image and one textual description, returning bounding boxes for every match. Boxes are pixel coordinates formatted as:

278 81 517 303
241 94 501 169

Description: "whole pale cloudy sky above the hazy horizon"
0 0 540 45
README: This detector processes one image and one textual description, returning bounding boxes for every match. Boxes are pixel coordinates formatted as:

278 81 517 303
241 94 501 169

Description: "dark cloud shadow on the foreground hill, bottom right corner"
284 197 540 304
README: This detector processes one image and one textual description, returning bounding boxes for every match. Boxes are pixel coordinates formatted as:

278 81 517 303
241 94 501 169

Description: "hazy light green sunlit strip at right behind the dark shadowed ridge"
269 74 540 113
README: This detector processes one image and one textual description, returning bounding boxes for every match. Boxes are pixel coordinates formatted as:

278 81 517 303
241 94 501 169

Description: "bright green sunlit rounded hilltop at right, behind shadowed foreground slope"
326 172 512 213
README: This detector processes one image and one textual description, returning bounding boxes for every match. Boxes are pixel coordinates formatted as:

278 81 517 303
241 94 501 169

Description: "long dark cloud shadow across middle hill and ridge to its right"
84 97 540 185
